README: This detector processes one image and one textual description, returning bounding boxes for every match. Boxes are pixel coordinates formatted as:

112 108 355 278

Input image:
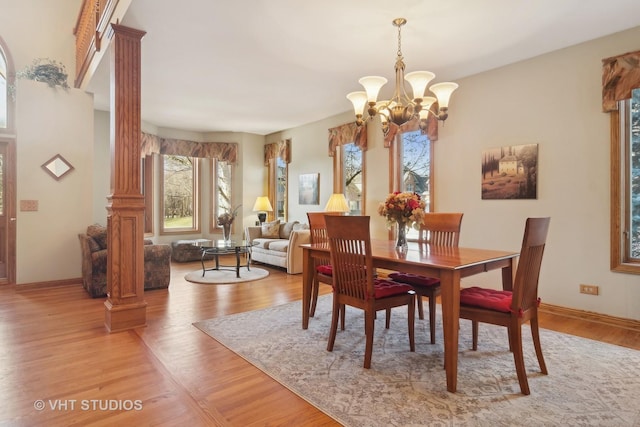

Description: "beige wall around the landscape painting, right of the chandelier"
435 28 640 319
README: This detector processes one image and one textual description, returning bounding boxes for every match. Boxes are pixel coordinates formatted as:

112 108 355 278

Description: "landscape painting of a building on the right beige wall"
482 144 538 200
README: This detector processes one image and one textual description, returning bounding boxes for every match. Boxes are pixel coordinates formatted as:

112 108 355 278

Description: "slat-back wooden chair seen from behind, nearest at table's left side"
325 216 416 369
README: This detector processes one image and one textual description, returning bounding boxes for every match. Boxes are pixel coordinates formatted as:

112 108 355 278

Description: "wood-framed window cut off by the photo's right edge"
611 88 640 274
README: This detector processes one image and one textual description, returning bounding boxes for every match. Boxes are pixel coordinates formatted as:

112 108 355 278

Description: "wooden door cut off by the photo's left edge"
0 138 16 285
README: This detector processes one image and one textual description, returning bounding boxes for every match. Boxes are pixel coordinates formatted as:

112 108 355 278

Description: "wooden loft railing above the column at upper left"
73 0 122 87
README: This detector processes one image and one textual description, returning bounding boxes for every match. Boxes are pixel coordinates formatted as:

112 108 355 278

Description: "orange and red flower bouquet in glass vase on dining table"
378 191 426 248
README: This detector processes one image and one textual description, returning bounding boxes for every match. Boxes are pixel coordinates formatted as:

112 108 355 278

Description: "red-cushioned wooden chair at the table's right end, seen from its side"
460 218 550 395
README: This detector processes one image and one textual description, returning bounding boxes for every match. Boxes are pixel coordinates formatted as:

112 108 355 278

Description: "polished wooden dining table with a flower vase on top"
300 239 520 393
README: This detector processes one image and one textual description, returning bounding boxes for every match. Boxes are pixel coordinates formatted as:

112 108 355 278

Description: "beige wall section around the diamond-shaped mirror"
16 80 93 283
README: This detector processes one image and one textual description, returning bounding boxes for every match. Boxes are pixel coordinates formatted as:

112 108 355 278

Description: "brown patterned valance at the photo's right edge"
602 51 640 113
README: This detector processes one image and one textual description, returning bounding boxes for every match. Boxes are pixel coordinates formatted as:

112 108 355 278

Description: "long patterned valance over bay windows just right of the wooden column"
140 132 238 164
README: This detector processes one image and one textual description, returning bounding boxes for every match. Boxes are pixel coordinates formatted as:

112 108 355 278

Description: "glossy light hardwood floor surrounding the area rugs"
0 263 640 427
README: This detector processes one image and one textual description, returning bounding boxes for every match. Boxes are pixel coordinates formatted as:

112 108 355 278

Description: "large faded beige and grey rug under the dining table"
194 296 640 427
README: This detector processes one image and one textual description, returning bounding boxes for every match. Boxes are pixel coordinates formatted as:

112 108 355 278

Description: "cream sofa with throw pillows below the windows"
245 221 311 274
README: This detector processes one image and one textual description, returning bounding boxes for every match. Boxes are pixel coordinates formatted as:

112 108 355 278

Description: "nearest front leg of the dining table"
440 270 460 393
